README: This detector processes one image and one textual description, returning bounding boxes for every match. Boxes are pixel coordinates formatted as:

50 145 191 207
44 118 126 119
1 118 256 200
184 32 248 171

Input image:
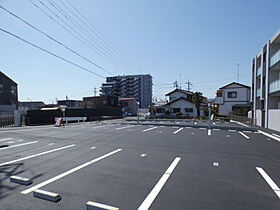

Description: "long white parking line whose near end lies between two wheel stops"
21 149 122 195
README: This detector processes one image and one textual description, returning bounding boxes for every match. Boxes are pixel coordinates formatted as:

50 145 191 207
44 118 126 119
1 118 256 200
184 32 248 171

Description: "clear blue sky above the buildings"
0 0 280 103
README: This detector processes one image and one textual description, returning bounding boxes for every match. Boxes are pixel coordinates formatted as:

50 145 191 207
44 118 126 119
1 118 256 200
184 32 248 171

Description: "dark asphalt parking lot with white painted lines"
0 121 280 210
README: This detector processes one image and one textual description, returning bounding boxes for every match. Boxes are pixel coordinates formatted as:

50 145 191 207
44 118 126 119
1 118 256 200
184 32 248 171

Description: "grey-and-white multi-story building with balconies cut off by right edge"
251 30 280 131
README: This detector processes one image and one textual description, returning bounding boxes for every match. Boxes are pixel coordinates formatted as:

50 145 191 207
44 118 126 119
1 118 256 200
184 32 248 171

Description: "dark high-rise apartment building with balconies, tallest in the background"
101 74 153 108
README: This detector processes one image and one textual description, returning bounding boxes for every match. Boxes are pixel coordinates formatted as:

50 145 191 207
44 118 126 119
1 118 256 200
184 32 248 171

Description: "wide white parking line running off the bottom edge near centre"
138 157 181 210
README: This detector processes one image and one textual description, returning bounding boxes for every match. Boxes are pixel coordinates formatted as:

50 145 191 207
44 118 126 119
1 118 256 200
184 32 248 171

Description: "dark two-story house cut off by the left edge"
0 71 18 115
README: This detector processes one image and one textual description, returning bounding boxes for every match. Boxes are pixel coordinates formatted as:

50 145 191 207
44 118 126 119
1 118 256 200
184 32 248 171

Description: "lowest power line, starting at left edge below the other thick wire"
0 28 105 79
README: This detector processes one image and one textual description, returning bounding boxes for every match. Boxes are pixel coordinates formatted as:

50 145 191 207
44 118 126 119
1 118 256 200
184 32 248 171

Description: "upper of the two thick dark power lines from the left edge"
0 6 112 74
